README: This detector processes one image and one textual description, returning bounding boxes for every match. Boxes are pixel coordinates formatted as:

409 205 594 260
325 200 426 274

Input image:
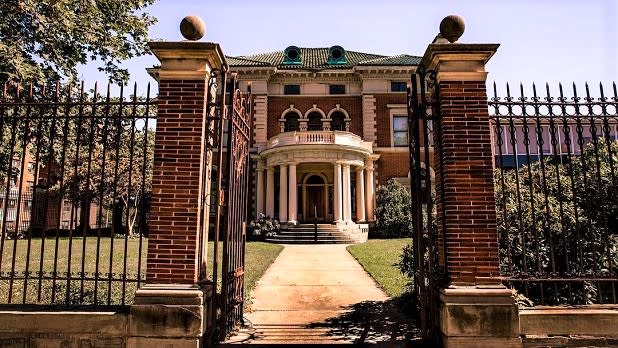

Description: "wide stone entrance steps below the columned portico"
266 224 358 244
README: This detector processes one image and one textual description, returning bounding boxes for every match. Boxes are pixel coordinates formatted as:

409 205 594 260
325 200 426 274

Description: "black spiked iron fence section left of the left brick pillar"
0 83 156 305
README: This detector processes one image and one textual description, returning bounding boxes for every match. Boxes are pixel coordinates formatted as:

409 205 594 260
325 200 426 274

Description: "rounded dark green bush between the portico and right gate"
373 179 412 238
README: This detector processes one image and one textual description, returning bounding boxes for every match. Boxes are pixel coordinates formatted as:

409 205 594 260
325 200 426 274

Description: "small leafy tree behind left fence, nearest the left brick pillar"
39 96 154 235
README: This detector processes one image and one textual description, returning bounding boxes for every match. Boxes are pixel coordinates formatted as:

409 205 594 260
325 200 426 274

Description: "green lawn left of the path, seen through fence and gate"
0 237 283 304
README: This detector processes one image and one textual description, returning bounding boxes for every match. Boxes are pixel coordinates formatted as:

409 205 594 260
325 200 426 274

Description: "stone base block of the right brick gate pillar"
438 286 522 348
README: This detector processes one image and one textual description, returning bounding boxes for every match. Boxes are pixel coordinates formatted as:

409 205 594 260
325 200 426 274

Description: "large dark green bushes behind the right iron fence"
495 139 618 304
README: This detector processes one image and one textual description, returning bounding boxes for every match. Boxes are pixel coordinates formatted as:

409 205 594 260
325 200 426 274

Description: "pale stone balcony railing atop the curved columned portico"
268 131 372 150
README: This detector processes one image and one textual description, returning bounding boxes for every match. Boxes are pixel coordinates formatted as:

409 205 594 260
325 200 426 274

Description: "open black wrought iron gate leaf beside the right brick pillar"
408 65 446 341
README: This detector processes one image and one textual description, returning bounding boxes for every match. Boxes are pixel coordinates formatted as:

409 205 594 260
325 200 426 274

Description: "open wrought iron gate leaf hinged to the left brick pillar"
203 71 251 340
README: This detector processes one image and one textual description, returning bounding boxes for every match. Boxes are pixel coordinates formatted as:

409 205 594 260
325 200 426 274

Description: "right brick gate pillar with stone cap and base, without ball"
422 17 521 347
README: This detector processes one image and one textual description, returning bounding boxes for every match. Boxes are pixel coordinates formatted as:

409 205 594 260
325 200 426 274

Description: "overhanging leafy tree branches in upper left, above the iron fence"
0 0 156 83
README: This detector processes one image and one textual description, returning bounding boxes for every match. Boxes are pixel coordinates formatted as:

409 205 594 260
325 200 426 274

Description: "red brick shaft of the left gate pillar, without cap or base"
146 80 206 284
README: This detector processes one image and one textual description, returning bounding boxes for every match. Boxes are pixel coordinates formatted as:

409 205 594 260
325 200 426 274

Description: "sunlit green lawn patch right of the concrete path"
348 238 412 298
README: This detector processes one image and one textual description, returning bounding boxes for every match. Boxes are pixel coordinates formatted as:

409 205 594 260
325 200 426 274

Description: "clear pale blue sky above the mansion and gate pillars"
81 0 618 95
